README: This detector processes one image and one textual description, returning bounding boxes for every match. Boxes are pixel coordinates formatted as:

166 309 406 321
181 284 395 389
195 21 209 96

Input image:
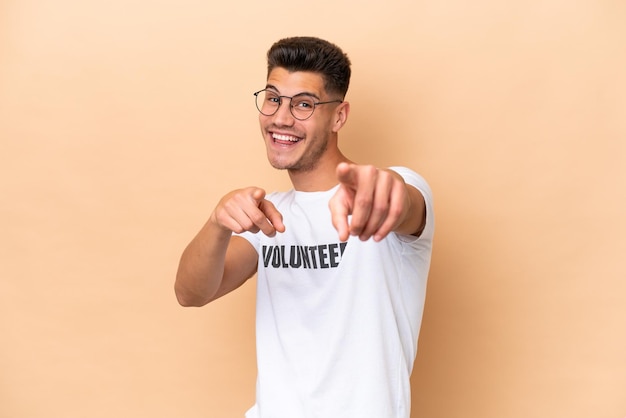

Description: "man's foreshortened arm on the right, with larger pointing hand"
329 163 426 241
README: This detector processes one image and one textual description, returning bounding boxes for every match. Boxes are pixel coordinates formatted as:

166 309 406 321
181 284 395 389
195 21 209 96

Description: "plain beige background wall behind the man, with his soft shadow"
0 0 626 418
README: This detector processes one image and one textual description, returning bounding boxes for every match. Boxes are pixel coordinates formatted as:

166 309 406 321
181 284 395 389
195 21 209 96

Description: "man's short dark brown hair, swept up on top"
267 36 351 99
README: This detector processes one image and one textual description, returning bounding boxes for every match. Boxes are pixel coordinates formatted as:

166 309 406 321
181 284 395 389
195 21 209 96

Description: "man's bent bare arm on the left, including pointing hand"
174 187 284 306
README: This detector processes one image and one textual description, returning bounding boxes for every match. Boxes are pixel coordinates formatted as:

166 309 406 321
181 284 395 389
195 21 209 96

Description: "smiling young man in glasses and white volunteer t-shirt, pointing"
175 37 433 418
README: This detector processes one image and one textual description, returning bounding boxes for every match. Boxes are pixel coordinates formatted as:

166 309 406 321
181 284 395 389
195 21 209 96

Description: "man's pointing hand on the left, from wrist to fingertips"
210 187 285 237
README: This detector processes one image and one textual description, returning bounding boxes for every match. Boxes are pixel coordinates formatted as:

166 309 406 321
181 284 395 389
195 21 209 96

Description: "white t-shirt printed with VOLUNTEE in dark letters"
236 167 434 418
